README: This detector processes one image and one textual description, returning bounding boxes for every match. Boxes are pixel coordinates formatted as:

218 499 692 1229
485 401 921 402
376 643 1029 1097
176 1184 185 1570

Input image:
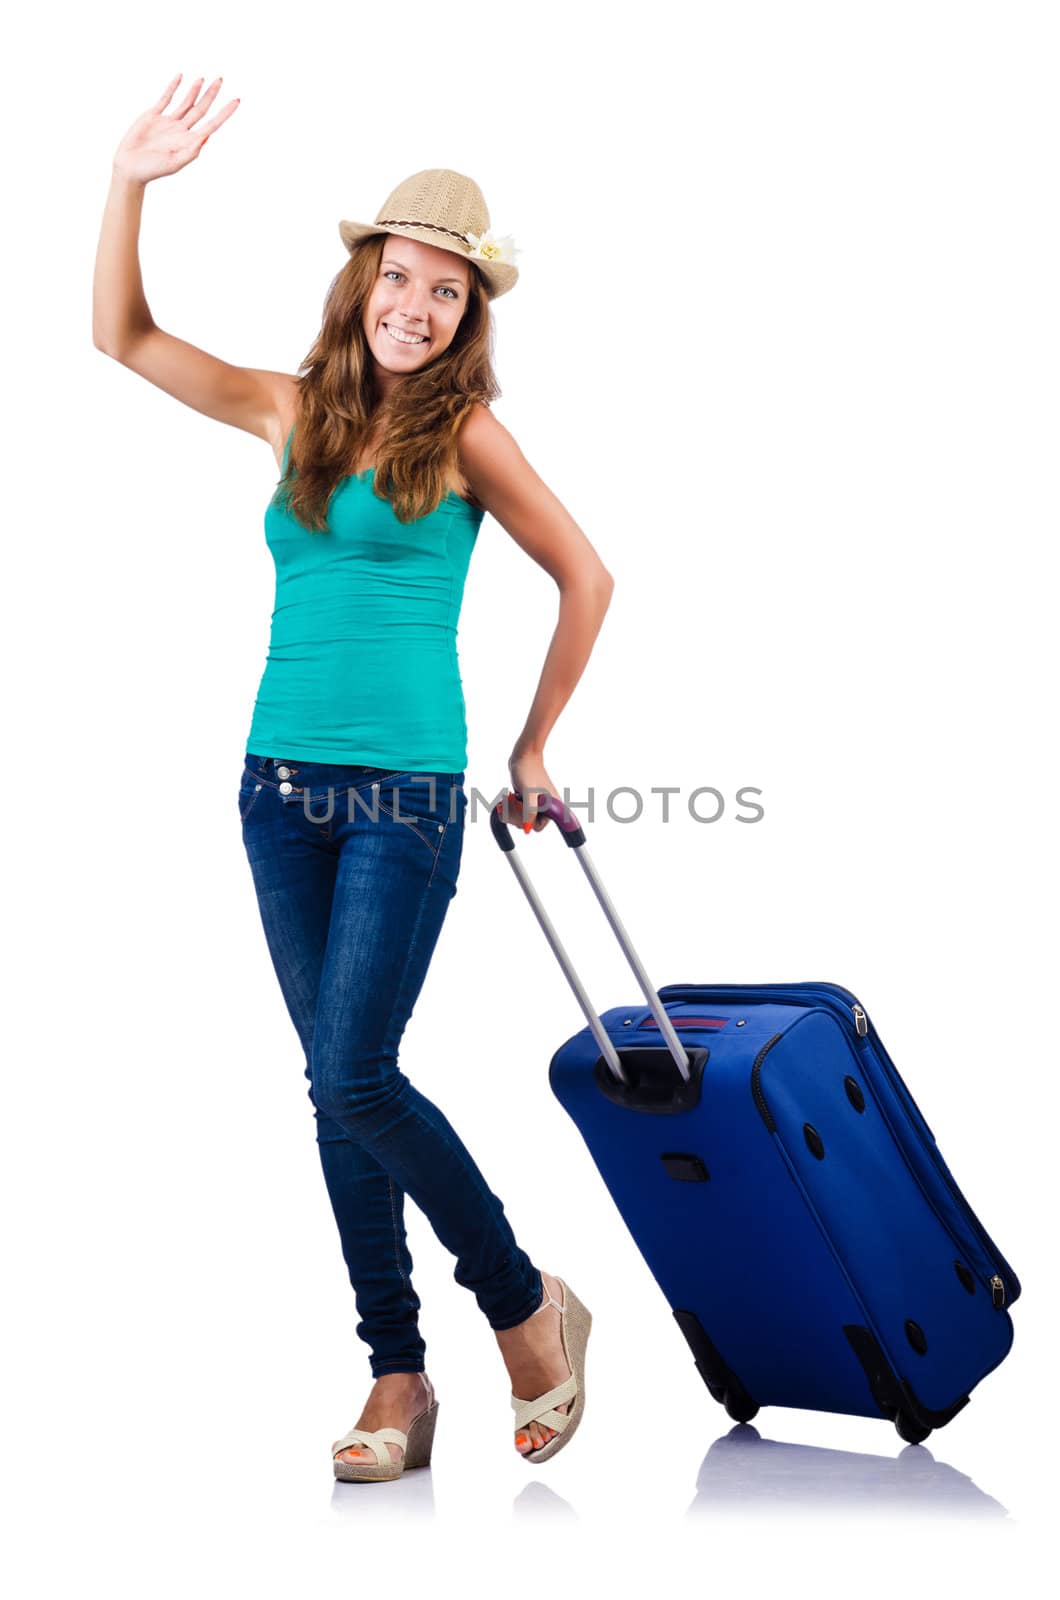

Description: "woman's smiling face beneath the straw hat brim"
363 234 471 387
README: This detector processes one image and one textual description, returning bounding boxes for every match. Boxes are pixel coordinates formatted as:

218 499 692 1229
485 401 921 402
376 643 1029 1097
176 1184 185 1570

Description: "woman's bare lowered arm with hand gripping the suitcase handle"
460 405 615 832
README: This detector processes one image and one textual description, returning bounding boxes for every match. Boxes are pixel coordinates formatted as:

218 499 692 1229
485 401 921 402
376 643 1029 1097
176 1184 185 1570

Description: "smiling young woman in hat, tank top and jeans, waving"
93 75 613 1480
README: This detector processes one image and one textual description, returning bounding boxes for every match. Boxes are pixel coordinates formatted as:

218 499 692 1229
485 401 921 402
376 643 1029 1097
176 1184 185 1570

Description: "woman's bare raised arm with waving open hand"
93 74 296 451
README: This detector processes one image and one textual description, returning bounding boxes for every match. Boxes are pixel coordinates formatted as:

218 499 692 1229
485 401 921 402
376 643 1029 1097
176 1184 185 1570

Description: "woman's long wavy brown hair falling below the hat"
275 234 501 533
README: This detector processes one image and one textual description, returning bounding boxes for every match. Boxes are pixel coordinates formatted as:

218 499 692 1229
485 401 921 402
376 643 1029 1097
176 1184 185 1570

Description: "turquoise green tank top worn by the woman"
247 429 485 773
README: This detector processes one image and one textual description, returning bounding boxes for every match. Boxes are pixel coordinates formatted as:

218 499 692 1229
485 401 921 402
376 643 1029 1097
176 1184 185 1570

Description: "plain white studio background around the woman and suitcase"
2 0 1060 1595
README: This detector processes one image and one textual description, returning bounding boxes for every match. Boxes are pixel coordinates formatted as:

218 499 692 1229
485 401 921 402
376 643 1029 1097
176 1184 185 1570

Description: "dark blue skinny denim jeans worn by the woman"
239 754 543 1378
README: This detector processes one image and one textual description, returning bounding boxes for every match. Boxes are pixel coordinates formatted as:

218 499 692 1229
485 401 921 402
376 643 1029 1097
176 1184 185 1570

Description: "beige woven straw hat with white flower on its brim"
338 166 519 299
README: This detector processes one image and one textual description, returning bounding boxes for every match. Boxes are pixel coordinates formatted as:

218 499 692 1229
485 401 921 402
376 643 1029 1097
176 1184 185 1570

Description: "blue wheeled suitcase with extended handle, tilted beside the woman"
490 795 1020 1443
